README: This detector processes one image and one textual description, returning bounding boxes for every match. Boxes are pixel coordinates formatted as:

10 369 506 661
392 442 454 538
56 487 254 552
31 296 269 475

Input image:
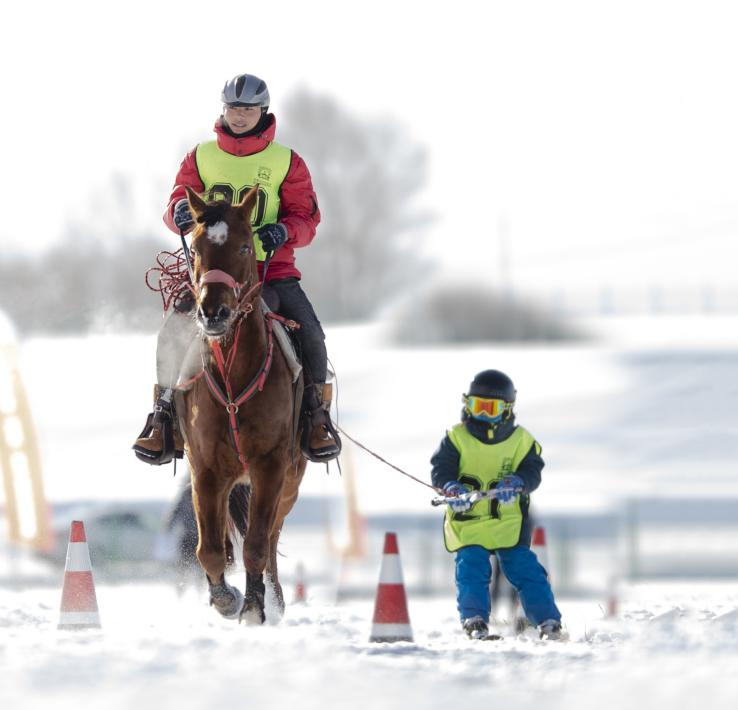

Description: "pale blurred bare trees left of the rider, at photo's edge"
0 175 168 334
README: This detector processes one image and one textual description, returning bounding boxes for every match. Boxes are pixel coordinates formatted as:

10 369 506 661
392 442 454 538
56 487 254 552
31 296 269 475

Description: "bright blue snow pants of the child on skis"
456 545 561 626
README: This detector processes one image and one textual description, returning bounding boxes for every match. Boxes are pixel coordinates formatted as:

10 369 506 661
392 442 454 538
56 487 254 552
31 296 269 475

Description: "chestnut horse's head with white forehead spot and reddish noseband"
187 187 261 338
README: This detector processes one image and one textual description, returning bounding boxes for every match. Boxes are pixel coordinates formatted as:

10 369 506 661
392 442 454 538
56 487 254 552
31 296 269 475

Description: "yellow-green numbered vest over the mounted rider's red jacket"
195 141 292 261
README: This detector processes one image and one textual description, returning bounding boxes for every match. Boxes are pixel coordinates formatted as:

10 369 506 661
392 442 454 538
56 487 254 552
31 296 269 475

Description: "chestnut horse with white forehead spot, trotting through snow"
180 187 307 624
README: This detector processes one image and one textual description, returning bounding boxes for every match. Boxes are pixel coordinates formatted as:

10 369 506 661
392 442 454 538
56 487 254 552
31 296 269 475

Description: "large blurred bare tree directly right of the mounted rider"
278 89 431 321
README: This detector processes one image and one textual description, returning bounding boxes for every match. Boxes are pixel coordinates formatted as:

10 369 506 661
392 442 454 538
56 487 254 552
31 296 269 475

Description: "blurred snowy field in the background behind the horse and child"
12 316 738 513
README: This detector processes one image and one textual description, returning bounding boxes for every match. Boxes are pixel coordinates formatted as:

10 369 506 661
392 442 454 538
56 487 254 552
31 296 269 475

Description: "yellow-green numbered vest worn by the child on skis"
443 423 540 552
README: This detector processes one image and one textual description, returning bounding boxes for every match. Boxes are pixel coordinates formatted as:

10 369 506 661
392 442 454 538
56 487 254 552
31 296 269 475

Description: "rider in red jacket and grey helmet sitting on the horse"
133 74 341 464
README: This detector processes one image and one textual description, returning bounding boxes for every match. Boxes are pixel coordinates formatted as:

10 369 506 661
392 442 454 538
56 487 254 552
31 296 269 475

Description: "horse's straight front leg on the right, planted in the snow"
241 466 282 624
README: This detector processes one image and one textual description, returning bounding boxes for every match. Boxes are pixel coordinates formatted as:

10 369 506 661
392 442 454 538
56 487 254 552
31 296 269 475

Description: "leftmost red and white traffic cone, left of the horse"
57 520 100 629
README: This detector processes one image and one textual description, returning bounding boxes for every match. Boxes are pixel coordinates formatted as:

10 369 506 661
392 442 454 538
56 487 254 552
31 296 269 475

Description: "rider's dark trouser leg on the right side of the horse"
262 277 328 385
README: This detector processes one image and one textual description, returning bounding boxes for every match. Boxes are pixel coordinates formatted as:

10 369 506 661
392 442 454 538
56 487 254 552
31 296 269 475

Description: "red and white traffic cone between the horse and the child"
369 533 413 643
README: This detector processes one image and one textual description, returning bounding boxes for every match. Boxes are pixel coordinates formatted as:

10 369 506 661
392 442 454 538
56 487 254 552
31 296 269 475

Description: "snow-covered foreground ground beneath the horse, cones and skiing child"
0 585 738 710
